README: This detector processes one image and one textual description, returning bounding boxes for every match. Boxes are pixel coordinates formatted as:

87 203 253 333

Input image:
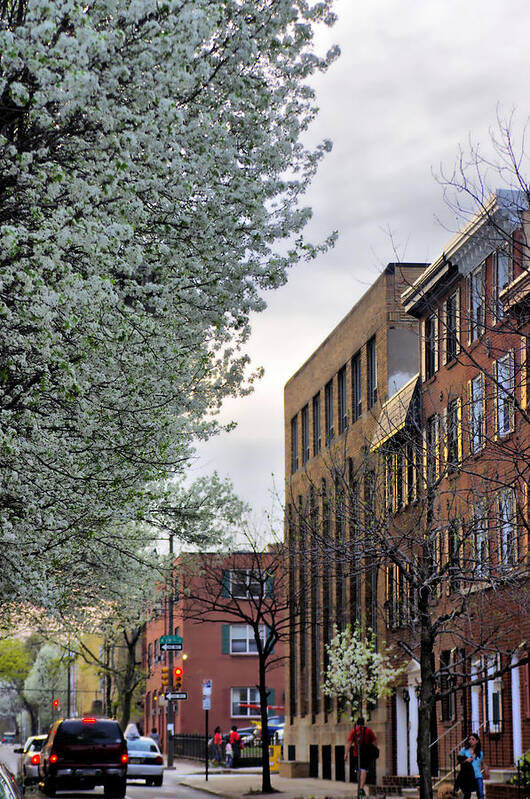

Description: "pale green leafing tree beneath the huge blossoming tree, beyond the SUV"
27 474 245 729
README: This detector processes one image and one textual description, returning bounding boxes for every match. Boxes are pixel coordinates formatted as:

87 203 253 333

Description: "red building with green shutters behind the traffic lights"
143 553 285 751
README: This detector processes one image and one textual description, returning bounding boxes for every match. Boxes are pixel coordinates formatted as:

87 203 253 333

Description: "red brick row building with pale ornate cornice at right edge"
385 192 530 778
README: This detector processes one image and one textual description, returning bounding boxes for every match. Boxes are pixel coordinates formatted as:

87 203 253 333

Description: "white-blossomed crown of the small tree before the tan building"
324 625 400 719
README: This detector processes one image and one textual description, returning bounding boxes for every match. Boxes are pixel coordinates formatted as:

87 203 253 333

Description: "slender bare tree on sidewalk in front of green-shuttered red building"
177 536 292 793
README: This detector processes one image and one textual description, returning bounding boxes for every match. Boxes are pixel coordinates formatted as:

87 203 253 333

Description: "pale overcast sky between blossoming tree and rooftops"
192 0 530 532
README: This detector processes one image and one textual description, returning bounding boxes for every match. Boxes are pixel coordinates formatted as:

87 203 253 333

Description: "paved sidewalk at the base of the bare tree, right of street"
164 760 357 799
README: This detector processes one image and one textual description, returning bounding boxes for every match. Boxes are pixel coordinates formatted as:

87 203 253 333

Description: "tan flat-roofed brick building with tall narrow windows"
284 264 426 779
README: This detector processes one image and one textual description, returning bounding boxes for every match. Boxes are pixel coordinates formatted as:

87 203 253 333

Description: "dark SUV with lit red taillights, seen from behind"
39 718 128 799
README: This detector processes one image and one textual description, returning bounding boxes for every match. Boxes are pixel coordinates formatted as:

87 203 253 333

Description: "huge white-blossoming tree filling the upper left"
0 0 335 607
